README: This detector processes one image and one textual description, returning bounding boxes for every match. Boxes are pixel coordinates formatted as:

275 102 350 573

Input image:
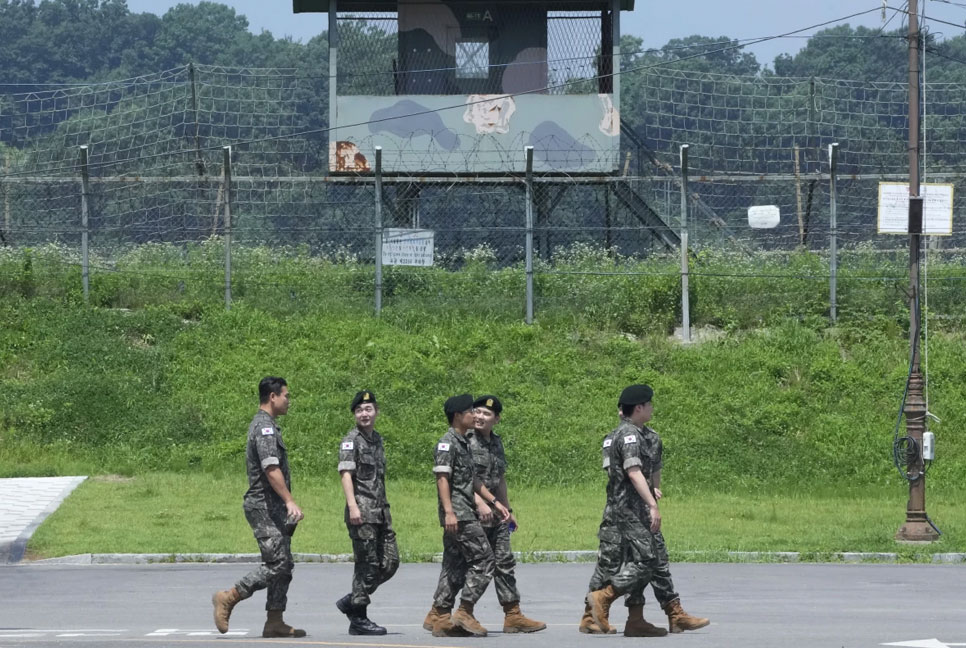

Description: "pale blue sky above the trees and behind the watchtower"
127 0 966 67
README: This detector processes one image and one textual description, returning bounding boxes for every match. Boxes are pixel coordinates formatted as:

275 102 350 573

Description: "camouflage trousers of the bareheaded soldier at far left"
235 508 295 610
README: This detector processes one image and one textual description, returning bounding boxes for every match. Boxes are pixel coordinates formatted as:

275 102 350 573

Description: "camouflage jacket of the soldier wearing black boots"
339 428 390 524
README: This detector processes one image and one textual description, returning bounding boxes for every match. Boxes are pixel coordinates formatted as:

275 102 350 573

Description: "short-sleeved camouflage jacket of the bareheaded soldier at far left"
244 410 292 519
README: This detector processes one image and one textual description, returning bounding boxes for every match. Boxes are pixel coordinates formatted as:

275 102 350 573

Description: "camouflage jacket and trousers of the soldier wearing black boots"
338 428 399 607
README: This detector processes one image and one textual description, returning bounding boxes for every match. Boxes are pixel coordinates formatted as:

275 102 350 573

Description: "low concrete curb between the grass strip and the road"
23 551 966 565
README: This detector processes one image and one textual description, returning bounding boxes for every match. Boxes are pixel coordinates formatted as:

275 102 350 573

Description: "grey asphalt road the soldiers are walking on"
0 564 966 648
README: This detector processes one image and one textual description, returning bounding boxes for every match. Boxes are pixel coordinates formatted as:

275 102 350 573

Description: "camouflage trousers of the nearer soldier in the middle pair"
433 520 494 610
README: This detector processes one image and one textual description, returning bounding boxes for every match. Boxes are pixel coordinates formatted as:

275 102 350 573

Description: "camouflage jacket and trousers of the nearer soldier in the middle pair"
433 428 494 609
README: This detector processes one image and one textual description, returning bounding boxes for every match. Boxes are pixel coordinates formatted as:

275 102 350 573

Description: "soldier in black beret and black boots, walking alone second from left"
336 390 399 635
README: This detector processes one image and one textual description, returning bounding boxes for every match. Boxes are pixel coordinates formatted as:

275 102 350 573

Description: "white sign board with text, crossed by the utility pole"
879 182 953 236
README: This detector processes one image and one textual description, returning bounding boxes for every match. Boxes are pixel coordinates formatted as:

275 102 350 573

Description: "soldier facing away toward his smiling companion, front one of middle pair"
423 394 510 637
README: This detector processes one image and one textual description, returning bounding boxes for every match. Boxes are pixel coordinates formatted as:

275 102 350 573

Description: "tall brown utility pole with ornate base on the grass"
896 0 939 542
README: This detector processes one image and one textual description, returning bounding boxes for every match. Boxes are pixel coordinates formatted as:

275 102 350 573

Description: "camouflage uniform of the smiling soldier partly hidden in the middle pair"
469 432 520 605
